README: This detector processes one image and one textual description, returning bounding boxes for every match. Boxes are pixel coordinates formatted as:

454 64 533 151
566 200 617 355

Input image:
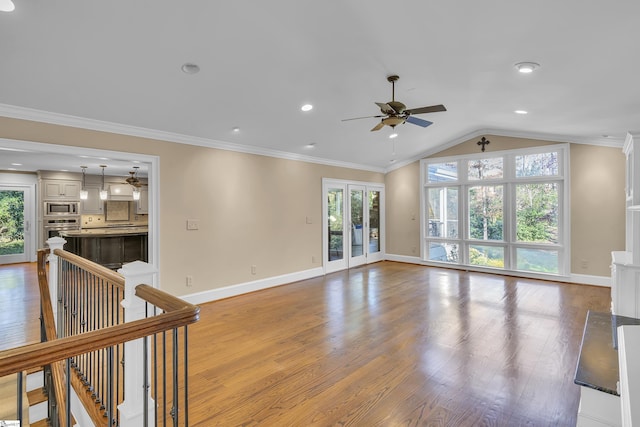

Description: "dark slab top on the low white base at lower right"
573 311 640 396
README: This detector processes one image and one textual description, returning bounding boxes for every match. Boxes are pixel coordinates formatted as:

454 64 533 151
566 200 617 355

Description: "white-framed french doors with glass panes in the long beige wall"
323 180 384 272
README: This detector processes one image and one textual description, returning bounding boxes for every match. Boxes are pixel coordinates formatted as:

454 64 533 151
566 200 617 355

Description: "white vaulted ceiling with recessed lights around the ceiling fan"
0 0 640 176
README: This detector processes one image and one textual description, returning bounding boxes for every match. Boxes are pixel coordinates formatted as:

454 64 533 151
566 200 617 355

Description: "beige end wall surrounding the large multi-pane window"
386 135 625 277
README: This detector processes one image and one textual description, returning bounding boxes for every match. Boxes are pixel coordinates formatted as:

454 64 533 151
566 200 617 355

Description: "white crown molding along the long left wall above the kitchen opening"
0 103 385 173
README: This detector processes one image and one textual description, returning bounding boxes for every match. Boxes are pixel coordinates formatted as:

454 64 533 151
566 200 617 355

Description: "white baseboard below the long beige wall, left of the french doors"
180 267 324 304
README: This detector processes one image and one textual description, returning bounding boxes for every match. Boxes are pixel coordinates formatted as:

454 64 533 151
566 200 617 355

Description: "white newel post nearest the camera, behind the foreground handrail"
118 261 157 427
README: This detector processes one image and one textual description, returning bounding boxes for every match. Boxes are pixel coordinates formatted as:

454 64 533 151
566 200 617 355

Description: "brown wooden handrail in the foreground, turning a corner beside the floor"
0 254 200 377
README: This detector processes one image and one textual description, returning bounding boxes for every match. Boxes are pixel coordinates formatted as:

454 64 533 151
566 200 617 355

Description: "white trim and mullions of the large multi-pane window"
420 143 571 279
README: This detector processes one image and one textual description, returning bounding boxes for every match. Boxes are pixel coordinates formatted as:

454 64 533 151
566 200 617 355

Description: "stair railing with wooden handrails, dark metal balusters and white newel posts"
0 246 199 427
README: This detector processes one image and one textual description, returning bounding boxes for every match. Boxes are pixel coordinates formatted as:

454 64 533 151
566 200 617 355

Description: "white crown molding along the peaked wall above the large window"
385 128 633 173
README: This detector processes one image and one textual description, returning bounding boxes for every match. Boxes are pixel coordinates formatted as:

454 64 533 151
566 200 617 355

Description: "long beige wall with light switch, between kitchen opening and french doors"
0 118 384 295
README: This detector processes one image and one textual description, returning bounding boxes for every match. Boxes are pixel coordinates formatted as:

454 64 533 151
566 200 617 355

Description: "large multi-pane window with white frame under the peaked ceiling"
421 144 569 275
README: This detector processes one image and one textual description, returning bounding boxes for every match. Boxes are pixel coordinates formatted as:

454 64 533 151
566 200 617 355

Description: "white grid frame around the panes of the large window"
420 143 571 277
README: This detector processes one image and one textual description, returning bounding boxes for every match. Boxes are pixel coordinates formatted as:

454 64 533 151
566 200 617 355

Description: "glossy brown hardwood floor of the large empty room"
0 262 610 426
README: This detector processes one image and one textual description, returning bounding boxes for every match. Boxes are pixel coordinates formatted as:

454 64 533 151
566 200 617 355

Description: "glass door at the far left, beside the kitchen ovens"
0 186 31 264
